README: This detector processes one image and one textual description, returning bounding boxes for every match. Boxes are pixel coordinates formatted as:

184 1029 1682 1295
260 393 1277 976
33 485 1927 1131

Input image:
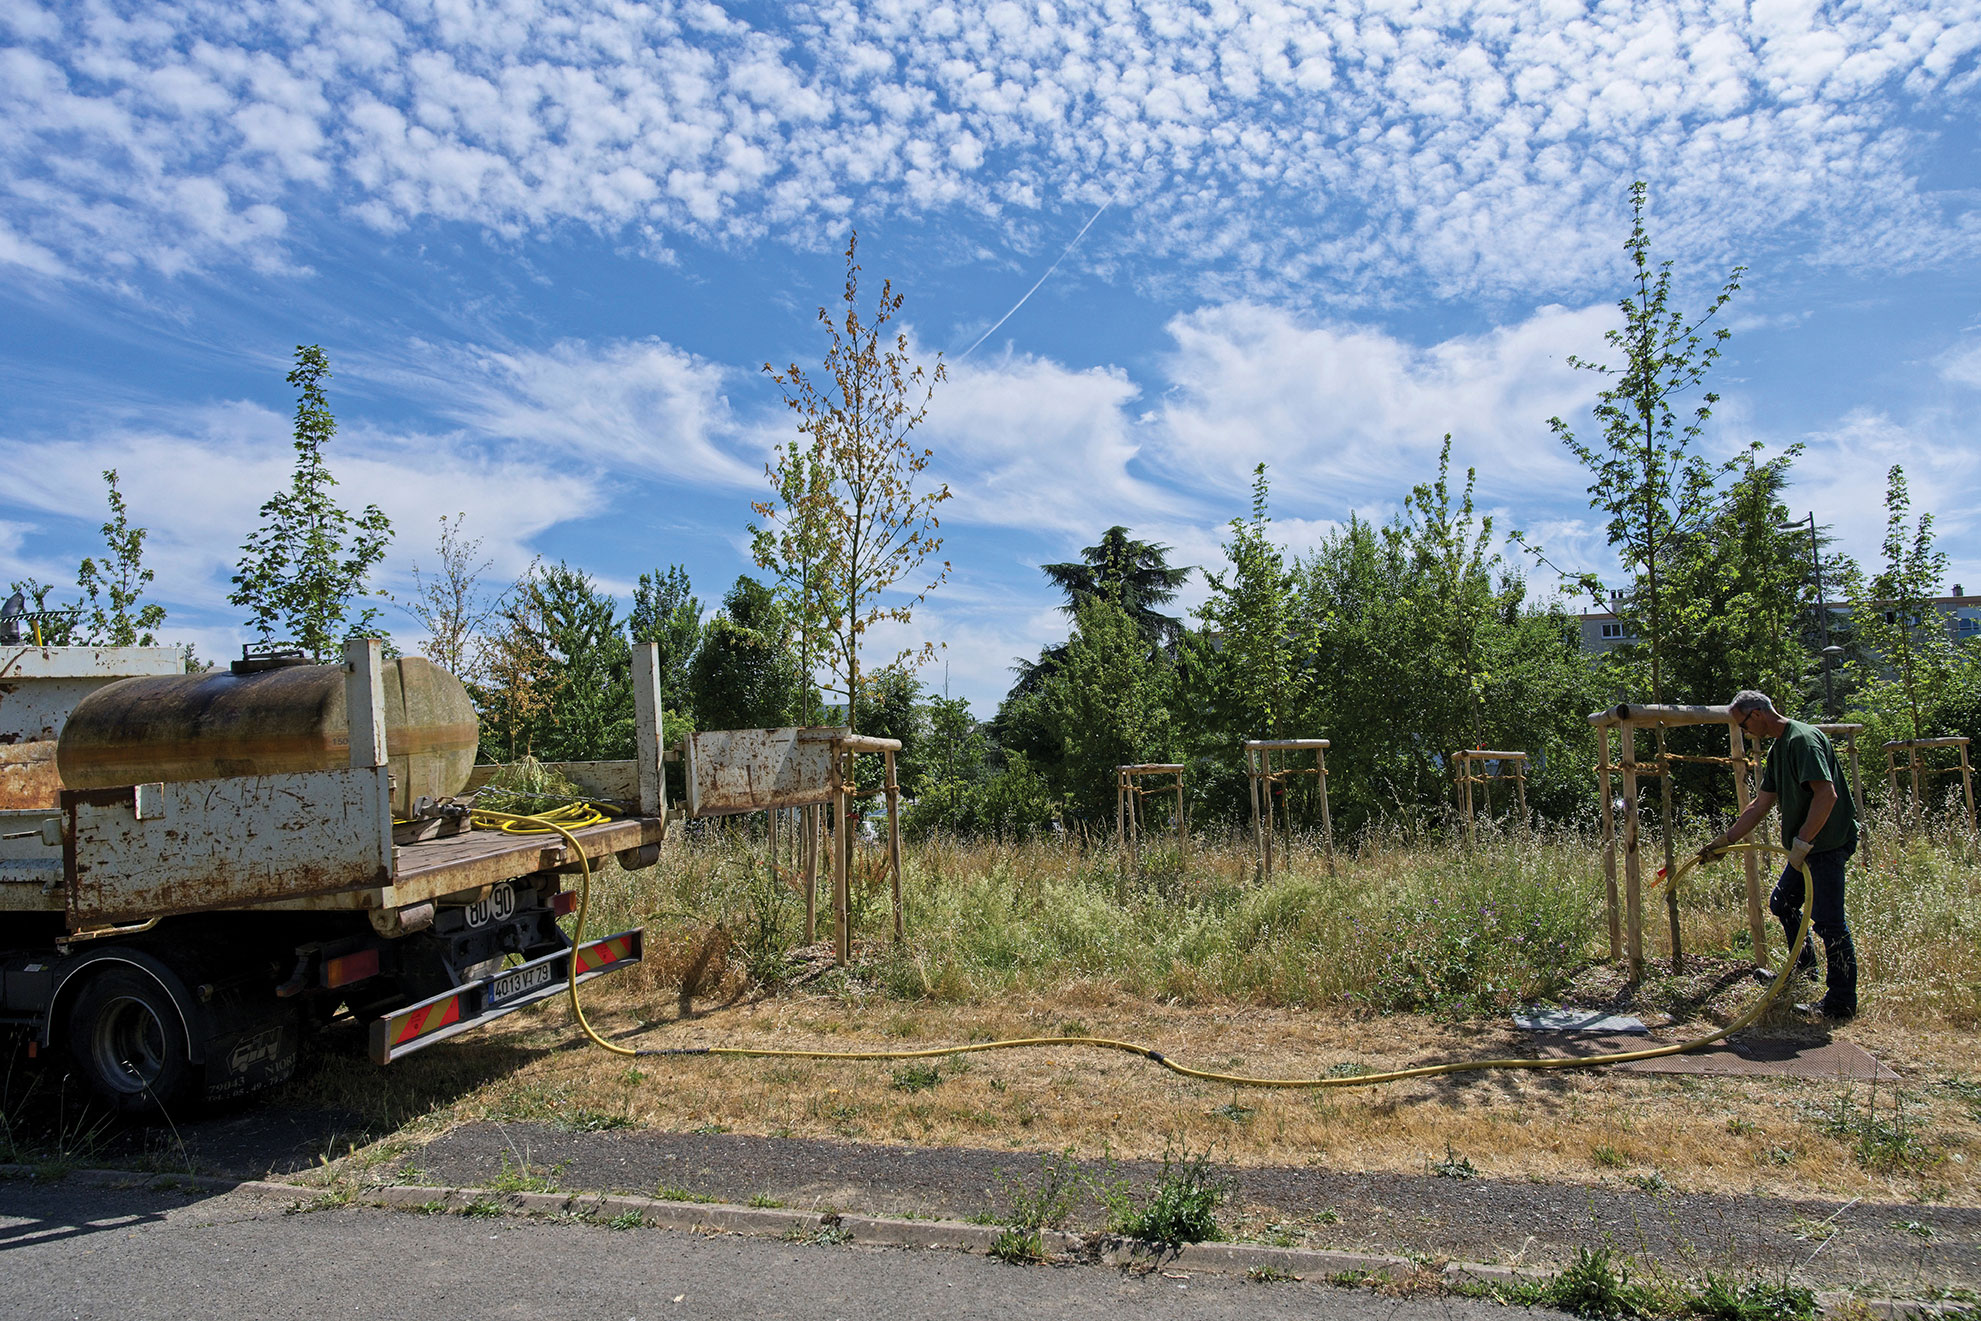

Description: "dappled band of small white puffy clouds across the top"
0 0 1981 297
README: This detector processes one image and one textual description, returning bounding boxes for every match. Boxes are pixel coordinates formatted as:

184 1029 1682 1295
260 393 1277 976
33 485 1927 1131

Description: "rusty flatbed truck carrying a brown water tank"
0 640 670 1113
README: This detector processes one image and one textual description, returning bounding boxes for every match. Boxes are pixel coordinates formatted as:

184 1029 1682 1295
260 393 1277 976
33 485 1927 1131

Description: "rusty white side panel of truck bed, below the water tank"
61 766 390 927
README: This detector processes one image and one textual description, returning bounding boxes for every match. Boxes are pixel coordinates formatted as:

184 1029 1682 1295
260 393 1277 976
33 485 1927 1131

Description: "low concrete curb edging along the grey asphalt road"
0 1165 1977 1321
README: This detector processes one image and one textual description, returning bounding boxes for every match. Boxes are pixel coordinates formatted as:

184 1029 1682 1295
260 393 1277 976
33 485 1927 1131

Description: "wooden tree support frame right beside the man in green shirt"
1589 703 1767 980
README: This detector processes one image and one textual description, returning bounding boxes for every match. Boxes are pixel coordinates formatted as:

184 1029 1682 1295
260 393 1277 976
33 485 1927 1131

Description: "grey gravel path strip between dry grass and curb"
396 1123 1981 1293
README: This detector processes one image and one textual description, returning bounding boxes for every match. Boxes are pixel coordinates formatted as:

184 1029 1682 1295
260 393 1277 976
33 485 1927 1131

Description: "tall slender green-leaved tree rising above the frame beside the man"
1547 182 1747 703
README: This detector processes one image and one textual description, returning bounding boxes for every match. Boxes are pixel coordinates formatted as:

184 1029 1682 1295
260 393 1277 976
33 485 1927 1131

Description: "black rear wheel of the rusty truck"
67 968 194 1115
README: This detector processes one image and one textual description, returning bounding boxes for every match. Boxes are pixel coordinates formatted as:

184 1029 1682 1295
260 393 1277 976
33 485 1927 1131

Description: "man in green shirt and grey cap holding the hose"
1700 689 1856 1020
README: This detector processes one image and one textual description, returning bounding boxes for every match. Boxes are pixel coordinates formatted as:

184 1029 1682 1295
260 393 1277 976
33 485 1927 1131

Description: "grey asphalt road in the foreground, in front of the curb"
0 1180 1545 1321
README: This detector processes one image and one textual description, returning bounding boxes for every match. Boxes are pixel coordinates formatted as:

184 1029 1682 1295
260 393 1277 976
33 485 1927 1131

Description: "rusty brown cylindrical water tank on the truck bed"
55 656 481 818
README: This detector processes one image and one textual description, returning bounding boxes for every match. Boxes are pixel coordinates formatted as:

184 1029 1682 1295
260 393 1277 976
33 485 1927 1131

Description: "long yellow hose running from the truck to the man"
459 819 1817 1089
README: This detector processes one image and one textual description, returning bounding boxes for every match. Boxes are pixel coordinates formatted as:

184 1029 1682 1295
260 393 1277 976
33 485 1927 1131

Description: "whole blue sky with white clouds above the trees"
0 0 1981 715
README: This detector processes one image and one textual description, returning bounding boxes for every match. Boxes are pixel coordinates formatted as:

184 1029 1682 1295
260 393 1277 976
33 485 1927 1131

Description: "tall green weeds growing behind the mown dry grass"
594 824 1981 1026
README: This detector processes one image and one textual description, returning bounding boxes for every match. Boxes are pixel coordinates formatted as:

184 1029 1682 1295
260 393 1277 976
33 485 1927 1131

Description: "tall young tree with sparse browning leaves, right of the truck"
763 234 949 728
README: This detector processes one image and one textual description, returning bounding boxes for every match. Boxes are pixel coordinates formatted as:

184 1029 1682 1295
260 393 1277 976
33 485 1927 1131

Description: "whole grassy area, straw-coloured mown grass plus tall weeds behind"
283 819 1981 1204
